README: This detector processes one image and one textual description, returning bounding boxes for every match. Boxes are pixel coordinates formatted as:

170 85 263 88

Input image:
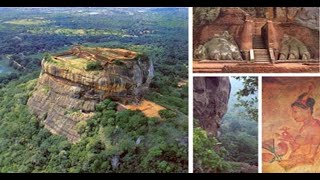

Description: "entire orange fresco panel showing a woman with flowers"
262 77 320 172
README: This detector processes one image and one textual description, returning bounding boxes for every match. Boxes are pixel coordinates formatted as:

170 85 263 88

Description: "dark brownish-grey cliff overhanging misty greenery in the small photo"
193 77 231 136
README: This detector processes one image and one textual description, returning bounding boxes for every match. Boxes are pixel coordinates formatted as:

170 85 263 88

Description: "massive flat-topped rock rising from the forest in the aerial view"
28 47 153 142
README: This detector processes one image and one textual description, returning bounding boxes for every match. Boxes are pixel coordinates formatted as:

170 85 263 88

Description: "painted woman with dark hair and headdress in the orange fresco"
279 86 320 170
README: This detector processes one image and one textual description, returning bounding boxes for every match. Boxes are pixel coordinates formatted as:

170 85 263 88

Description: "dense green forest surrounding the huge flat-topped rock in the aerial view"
0 8 188 172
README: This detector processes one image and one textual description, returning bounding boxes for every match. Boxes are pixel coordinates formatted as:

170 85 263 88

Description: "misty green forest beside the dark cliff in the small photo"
194 76 258 172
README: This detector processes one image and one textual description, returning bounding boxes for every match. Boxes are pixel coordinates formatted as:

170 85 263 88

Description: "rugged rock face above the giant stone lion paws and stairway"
194 7 319 30
